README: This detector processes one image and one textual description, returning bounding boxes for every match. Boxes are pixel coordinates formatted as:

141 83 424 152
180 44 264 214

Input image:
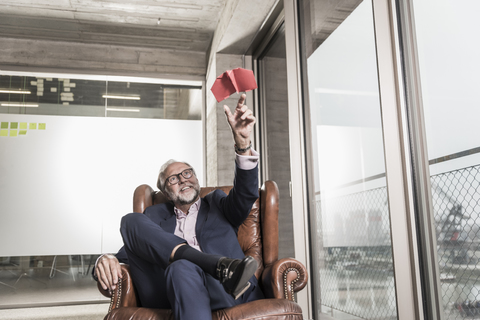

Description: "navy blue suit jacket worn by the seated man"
116 166 258 298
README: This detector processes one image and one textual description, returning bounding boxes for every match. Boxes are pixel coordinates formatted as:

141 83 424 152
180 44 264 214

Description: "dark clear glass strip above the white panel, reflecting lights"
0 74 201 120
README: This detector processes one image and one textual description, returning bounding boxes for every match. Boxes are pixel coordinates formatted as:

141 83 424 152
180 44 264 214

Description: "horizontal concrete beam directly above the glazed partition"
0 38 206 80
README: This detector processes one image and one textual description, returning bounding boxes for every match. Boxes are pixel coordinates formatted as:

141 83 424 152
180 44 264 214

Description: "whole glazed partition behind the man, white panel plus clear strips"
0 71 204 308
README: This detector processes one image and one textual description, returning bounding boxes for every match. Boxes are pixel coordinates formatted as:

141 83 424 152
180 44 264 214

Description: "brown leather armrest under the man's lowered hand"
97 264 138 312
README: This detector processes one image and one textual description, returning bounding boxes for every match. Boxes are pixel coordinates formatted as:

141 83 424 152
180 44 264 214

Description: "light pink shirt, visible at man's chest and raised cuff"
174 149 259 251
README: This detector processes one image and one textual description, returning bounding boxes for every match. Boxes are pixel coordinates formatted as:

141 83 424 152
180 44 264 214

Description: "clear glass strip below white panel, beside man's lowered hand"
0 255 105 309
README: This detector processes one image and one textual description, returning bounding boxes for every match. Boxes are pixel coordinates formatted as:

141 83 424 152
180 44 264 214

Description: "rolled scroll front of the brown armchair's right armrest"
262 258 308 301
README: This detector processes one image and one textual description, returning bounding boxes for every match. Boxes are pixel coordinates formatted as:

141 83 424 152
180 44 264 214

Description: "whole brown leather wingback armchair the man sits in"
98 181 308 320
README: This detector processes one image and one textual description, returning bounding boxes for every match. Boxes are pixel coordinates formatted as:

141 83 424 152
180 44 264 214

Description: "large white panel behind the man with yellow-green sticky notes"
0 114 204 256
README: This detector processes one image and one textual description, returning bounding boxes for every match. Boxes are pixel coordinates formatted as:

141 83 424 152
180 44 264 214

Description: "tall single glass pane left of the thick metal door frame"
301 0 397 319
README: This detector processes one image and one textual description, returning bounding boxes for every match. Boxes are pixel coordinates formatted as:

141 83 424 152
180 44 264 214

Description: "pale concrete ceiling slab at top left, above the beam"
0 0 227 52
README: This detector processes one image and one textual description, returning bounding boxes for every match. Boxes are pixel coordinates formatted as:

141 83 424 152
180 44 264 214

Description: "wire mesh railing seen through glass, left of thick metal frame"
317 188 396 319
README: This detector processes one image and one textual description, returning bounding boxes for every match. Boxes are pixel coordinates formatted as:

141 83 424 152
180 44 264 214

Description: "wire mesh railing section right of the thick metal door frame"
431 166 480 320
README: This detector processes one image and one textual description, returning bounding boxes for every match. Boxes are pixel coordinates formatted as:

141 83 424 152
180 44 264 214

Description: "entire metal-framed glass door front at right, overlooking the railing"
296 0 480 320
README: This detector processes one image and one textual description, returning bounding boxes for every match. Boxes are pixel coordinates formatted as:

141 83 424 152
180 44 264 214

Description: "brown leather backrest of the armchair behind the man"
133 181 278 279
